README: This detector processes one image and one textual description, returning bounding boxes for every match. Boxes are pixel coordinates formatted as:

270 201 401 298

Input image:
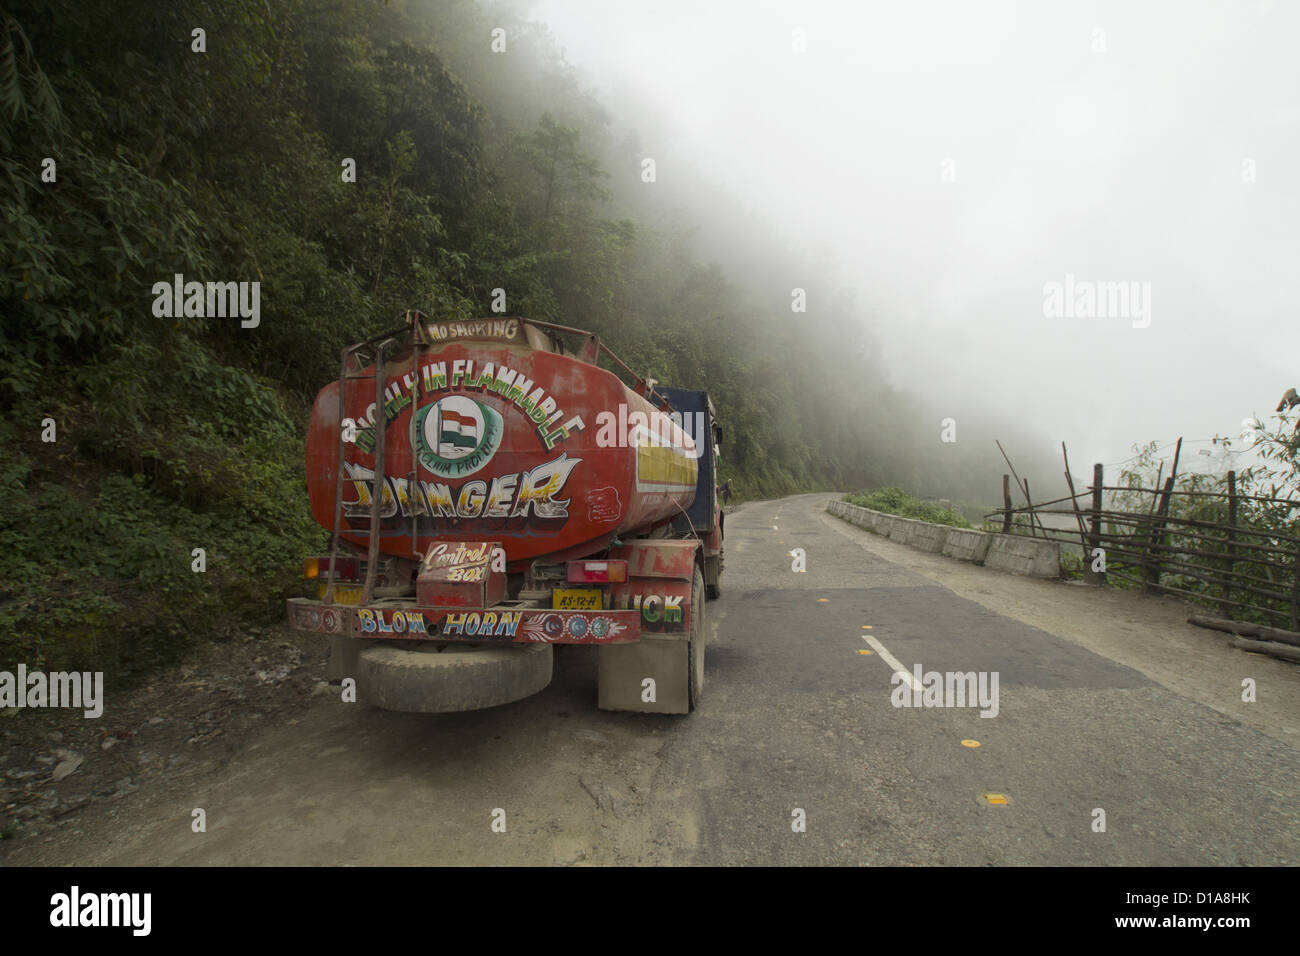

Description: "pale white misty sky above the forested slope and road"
525 0 1300 472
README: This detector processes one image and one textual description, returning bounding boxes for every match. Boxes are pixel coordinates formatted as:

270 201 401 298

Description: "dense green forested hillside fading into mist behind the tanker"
0 0 1055 675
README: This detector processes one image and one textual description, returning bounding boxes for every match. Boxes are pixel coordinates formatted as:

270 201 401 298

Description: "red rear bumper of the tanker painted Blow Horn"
285 597 641 644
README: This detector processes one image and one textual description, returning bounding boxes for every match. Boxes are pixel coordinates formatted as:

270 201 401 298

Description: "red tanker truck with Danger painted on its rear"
287 317 724 714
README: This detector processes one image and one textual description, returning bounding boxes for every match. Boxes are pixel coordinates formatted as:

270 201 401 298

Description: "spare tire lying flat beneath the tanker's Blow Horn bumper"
356 641 554 714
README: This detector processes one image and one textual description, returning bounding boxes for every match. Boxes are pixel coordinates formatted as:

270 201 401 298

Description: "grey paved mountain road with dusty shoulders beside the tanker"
12 496 1300 865
